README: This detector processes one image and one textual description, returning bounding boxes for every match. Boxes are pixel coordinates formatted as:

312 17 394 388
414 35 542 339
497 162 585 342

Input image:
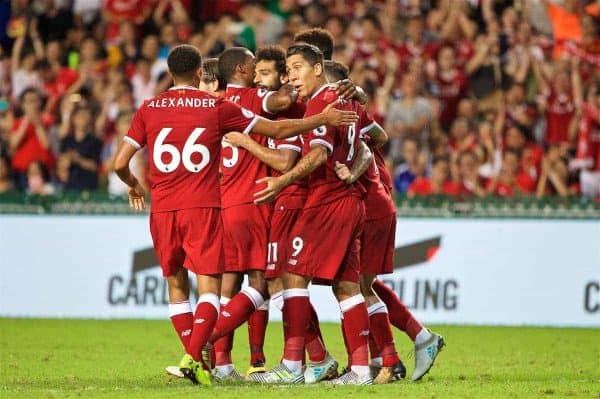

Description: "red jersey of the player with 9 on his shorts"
303 85 364 208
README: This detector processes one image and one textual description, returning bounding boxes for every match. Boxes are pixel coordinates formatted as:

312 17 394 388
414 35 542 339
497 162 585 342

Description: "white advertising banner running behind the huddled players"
0 215 600 327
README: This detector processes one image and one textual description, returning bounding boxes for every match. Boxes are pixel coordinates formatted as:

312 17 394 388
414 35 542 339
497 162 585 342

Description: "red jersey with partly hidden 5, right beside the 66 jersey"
221 84 273 208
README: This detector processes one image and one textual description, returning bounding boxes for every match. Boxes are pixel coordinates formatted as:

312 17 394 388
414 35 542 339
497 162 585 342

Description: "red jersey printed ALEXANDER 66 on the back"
125 86 259 212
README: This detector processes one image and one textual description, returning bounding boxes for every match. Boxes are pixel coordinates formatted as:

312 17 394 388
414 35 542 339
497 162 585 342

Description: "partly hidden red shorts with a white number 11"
265 208 302 279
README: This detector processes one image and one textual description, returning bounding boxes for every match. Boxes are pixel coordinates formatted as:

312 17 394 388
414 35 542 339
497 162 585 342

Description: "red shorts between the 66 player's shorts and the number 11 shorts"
222 204 272 272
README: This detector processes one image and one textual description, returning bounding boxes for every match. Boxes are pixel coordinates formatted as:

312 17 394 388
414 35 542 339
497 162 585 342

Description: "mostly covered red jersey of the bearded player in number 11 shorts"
268 100 308 210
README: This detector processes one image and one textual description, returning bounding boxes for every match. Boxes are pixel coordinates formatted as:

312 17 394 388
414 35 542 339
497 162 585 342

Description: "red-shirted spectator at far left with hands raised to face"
9 88 54 189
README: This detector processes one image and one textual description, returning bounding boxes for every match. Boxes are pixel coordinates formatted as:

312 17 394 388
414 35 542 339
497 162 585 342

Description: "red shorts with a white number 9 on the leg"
286 196 365 282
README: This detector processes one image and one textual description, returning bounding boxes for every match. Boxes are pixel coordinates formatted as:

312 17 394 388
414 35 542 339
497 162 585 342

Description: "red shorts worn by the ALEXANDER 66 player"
150 208 224 277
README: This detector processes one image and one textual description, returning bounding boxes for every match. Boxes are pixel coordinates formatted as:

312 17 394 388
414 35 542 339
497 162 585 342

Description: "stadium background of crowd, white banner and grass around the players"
0 0 600 397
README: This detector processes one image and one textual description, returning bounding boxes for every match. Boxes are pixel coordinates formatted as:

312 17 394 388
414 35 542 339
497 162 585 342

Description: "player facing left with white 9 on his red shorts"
256 44 373 385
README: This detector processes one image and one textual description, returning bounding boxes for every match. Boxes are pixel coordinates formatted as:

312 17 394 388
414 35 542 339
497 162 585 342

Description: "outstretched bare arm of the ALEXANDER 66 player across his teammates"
252 101 358 139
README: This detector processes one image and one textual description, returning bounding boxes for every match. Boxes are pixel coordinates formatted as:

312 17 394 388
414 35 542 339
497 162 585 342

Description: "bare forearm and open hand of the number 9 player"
254 144 327 204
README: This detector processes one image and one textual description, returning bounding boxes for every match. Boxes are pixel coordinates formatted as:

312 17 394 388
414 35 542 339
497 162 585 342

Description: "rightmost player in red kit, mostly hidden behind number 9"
325 61 445 384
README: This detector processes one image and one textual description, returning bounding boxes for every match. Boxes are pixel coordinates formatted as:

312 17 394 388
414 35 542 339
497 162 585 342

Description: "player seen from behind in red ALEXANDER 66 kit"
115 45 357 385
